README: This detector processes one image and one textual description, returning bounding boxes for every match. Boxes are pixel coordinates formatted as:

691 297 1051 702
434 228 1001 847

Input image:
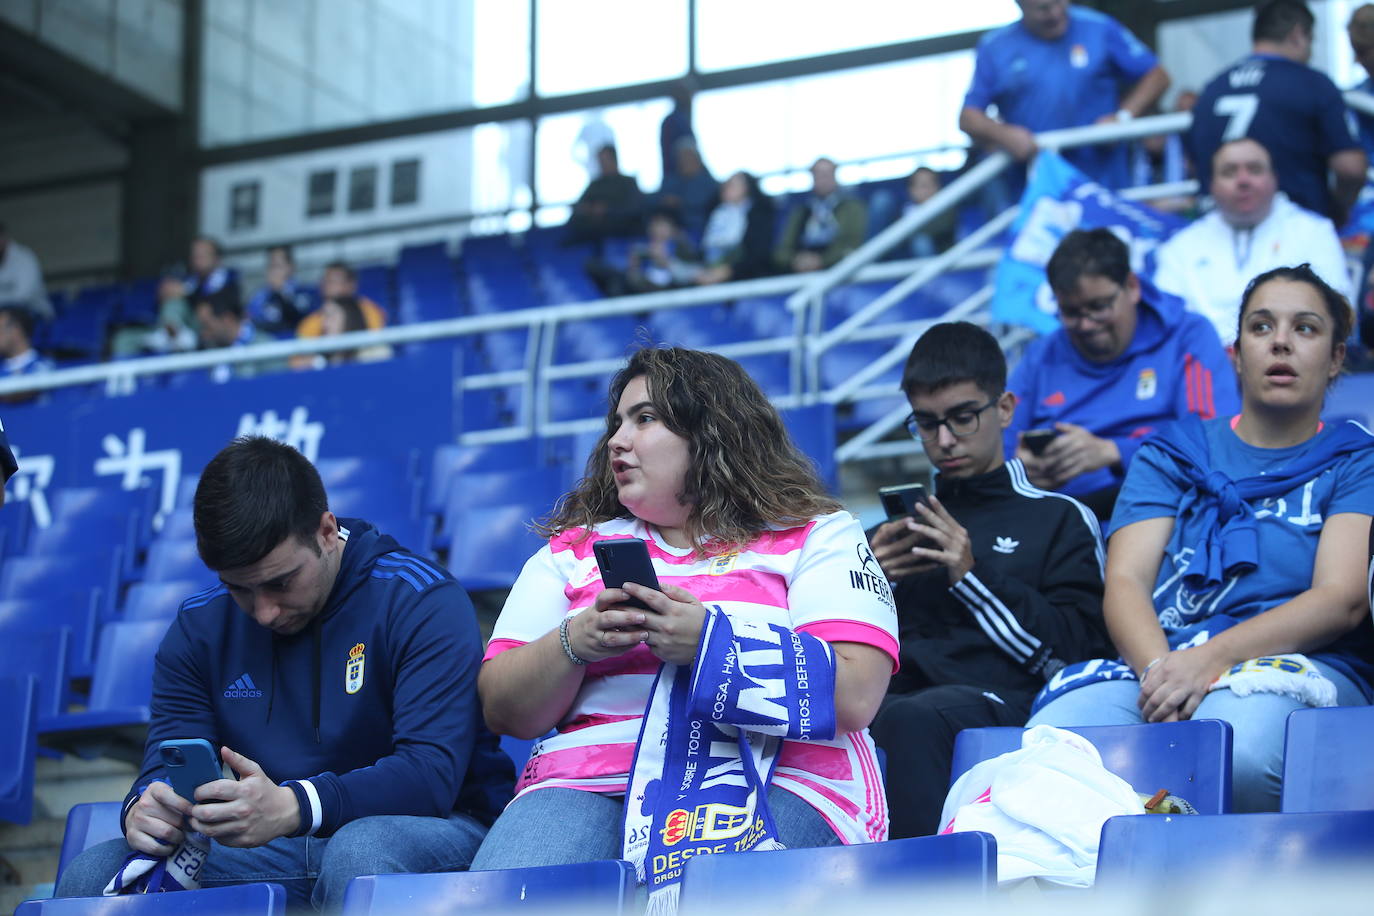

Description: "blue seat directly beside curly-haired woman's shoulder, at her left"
445 503 554 591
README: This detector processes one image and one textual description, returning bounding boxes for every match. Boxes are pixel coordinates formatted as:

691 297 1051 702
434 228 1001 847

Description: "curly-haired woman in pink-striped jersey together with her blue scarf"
473 347 897 908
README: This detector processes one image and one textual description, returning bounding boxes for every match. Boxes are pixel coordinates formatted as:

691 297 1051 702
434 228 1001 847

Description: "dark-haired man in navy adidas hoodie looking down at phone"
58 438 514 909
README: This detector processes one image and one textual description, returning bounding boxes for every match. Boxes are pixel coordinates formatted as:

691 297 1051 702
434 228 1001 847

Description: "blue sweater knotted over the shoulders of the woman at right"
1147 413 1374 592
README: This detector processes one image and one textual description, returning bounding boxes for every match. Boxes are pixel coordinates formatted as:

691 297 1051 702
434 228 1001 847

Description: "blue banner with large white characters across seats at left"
4 346 458 527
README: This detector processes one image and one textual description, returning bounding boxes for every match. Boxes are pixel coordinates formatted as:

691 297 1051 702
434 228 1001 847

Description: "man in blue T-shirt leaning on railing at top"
959 0 1169 192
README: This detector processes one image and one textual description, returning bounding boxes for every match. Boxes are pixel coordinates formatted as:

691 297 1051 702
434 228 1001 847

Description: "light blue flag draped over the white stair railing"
992 151 1187 334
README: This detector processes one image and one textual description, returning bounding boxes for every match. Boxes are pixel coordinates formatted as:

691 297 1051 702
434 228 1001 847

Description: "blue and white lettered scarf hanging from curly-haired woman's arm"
624 606 835 915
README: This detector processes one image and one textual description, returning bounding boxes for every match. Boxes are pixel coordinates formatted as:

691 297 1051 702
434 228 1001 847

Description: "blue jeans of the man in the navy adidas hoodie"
56 814 486 912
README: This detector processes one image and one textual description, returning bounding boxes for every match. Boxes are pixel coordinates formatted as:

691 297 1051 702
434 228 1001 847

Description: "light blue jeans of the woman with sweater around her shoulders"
1026 659 1366 813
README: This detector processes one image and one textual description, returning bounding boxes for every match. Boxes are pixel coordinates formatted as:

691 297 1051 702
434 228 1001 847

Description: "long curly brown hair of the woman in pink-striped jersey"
537 347 842 556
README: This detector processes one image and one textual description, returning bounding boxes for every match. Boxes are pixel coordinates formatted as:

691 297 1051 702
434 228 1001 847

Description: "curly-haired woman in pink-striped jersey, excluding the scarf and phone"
473 347 897 869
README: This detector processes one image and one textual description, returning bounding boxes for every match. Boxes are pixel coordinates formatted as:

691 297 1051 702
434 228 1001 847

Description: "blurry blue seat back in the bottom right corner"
1096 812 1374 889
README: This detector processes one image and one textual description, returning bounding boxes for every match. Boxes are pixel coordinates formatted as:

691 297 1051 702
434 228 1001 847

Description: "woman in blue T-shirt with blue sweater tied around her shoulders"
1029 264 1374 812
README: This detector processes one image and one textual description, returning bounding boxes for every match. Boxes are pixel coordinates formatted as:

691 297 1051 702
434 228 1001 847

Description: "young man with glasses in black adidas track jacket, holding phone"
870 321 1110 839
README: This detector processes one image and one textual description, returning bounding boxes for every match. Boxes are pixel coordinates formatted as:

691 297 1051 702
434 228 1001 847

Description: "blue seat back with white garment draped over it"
949 718 1231 814
